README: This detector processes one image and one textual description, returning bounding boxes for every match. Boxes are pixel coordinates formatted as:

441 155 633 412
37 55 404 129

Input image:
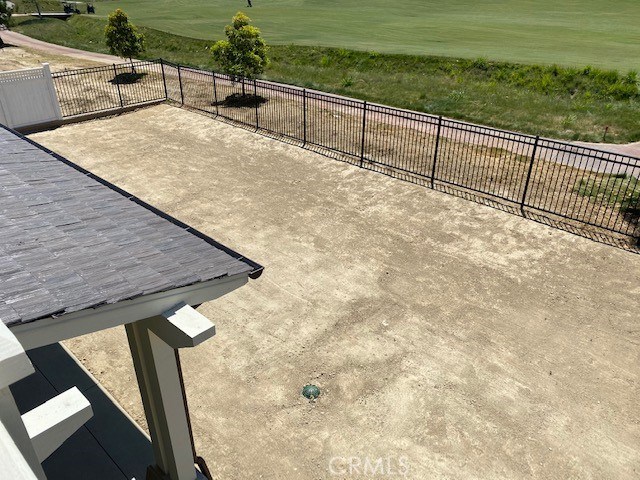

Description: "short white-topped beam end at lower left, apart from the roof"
22 387 93 462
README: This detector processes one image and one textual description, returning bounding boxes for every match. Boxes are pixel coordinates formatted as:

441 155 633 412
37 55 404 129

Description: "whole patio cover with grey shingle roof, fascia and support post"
0 126 262 479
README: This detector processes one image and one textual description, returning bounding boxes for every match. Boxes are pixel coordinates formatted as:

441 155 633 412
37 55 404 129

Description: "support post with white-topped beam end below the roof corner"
126 304 215 480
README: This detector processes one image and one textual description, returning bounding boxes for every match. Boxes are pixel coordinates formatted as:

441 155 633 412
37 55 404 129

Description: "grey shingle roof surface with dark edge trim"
0 124 262 326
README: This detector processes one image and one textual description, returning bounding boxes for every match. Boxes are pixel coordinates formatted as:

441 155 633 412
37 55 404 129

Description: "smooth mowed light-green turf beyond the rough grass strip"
91 0 640 71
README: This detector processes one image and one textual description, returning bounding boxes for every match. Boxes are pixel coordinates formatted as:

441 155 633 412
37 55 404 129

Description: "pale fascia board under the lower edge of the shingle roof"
10 273 249 350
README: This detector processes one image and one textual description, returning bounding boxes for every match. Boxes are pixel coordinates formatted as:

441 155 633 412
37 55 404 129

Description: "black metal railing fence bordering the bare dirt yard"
53 60 640 246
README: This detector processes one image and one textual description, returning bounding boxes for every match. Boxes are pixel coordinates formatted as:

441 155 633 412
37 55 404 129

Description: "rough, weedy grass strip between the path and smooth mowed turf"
8 16 640 143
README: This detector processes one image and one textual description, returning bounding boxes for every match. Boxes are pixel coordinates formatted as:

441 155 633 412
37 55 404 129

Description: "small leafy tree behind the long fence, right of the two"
211 12 269 96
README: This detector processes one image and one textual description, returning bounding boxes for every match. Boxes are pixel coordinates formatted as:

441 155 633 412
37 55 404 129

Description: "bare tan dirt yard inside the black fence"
32 105 640 480
